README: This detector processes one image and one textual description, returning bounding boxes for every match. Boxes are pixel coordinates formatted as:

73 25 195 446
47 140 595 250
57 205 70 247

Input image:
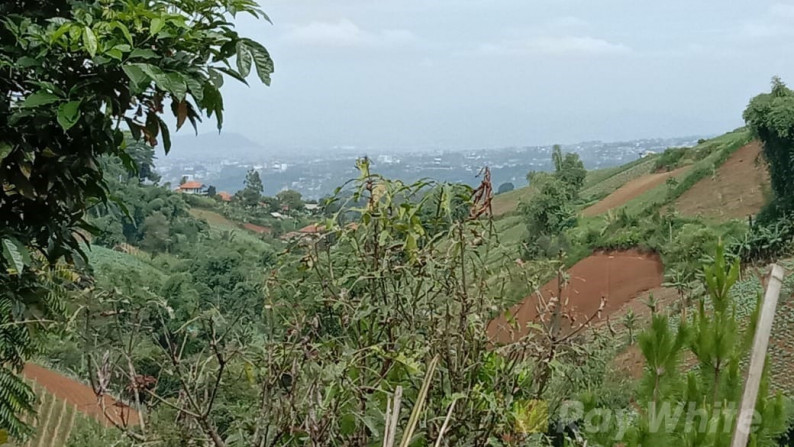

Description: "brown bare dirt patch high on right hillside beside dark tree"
675 141 769 220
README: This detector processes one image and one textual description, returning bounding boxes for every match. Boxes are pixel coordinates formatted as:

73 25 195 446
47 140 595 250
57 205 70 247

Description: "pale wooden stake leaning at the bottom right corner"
731 264 784 447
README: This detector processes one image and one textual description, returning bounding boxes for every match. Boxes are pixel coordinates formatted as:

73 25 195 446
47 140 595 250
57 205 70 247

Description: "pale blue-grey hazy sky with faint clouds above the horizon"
192 0 794 150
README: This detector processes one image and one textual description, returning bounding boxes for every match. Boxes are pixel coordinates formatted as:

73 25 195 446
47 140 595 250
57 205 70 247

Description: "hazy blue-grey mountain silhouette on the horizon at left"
169 132 272 159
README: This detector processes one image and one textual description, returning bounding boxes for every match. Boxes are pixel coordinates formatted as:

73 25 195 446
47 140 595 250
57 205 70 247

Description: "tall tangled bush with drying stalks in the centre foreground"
66 161 613 447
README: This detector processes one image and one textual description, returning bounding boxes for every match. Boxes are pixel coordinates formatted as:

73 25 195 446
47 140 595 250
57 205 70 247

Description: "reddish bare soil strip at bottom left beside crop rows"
22 363 139 426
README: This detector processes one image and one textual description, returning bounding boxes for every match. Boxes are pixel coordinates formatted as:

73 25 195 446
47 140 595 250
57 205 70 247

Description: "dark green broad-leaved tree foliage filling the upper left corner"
0 0 273 434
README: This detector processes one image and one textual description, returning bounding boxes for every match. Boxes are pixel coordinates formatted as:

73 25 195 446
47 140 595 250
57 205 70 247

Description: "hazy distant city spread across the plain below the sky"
155 134 699 199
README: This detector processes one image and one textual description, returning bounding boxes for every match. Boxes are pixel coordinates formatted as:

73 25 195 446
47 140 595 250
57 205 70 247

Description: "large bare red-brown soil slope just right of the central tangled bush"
488 250 664 343
